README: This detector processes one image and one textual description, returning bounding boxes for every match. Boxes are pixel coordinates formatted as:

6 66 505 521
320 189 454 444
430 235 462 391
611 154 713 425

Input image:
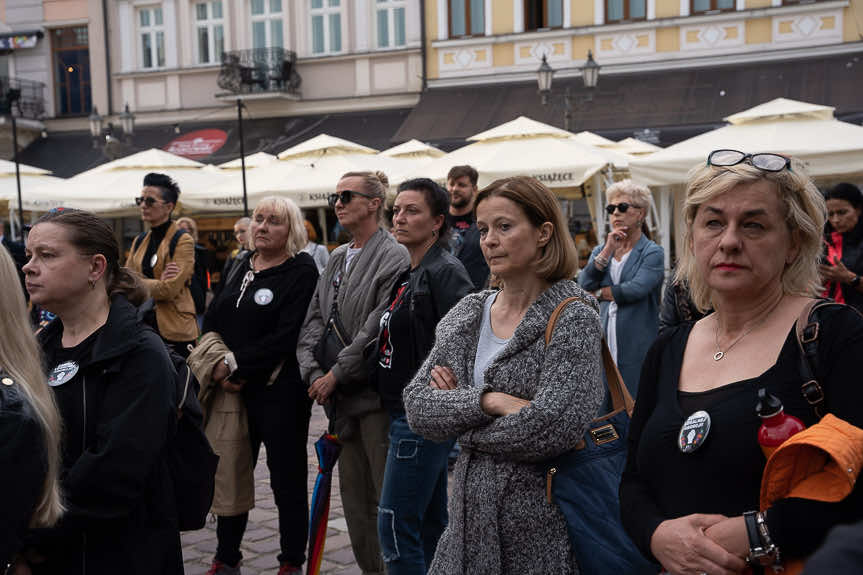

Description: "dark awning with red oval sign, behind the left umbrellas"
19 109 410 178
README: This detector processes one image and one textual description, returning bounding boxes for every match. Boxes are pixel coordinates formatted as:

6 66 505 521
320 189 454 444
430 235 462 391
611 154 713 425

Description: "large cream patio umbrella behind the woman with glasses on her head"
630 98 863 186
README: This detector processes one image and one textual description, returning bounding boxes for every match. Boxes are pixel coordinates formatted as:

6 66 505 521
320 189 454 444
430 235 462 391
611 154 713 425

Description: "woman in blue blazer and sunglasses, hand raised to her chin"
578 180 664 397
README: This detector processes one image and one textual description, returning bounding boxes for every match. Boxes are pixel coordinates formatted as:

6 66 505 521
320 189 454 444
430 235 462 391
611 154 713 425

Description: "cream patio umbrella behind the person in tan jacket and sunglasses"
28 149 225 217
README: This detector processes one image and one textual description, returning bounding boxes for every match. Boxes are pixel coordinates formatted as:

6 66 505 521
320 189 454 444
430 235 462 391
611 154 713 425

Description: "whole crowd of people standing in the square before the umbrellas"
0 150 863 575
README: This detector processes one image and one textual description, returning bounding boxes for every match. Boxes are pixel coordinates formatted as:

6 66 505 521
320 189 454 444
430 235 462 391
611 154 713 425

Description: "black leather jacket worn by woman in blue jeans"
375 244 474 413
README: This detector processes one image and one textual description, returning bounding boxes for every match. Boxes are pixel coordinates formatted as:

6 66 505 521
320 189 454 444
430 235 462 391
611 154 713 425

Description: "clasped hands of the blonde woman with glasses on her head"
650 513 748 575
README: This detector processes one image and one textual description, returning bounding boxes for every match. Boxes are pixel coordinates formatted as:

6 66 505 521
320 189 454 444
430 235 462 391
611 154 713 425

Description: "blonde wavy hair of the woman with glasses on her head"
676 160 827 311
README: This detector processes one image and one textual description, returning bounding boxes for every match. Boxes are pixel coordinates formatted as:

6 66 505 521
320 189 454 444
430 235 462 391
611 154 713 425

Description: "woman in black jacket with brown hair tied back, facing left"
20 209 183 575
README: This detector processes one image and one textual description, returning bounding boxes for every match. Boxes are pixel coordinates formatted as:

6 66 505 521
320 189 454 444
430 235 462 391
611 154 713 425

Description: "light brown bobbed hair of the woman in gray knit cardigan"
474 176 578 282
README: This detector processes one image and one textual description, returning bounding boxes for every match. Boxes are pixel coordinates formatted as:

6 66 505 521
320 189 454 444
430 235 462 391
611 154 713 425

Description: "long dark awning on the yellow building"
394 49 863 149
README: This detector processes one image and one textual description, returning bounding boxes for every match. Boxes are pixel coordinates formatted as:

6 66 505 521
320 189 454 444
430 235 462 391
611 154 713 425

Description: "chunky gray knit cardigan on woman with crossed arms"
403 280 603 575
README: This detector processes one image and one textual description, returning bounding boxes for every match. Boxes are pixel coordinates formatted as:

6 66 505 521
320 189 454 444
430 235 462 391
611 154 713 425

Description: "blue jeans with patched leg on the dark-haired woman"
378 415 453 575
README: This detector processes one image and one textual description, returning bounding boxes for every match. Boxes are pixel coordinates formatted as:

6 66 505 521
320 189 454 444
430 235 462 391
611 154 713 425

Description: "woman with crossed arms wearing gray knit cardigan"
404 177 603 575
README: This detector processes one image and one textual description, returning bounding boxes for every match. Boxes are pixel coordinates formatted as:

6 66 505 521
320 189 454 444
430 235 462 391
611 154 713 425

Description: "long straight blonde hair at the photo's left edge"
0 249 63 527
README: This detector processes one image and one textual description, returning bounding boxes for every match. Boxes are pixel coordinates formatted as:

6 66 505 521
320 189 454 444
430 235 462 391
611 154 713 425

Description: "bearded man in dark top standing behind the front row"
446 166 488 291
